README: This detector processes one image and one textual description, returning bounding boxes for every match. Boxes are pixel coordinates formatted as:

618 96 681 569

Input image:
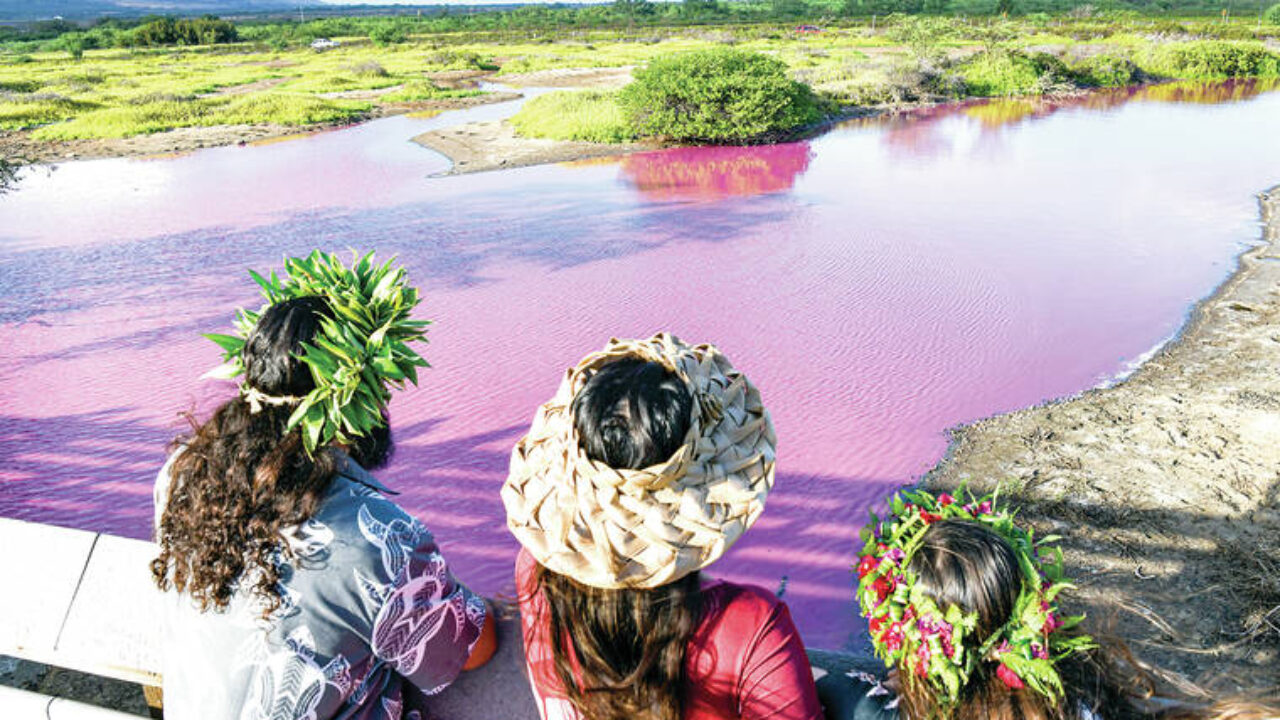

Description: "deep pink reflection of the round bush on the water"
621 142 810 200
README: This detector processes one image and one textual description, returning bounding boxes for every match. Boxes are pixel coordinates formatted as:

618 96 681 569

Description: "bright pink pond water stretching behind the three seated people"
0 83 1280 647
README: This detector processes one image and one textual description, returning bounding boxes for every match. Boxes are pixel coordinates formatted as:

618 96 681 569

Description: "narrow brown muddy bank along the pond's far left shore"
0 92 520 163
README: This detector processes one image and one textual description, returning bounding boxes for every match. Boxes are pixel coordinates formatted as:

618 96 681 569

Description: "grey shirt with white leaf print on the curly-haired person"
155 451 485 720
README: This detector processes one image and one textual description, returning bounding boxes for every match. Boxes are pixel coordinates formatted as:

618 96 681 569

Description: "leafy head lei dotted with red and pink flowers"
858 488 1096 706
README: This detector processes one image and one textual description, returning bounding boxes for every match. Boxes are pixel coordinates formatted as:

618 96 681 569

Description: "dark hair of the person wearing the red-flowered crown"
899 520 1275 720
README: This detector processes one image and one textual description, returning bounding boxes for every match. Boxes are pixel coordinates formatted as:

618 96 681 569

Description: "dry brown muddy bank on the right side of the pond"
924 187 1280 691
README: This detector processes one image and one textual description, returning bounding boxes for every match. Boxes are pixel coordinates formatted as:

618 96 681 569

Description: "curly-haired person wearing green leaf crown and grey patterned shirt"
151 251 495 720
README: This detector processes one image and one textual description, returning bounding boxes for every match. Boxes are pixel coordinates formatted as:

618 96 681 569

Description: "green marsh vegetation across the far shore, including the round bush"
0 8 1280 142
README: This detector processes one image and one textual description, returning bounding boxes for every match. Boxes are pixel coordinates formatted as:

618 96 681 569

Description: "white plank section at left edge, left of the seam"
0 518 96 662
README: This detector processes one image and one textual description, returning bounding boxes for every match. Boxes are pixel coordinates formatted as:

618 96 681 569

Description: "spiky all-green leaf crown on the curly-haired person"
205 250 430 452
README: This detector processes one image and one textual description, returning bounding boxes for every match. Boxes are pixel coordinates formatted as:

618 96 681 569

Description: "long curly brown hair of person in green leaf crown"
151 297 392 615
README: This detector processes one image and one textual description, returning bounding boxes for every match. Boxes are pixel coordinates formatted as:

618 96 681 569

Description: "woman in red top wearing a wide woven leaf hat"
502 334 822 720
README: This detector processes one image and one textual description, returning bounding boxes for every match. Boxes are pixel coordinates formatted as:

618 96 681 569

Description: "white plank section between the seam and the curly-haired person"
54 536 163 685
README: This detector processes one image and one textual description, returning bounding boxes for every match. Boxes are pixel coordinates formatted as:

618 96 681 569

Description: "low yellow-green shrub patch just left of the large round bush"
511 90 635 142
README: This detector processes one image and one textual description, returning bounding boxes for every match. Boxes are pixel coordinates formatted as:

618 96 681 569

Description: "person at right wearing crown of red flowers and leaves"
839 491 1280 720
